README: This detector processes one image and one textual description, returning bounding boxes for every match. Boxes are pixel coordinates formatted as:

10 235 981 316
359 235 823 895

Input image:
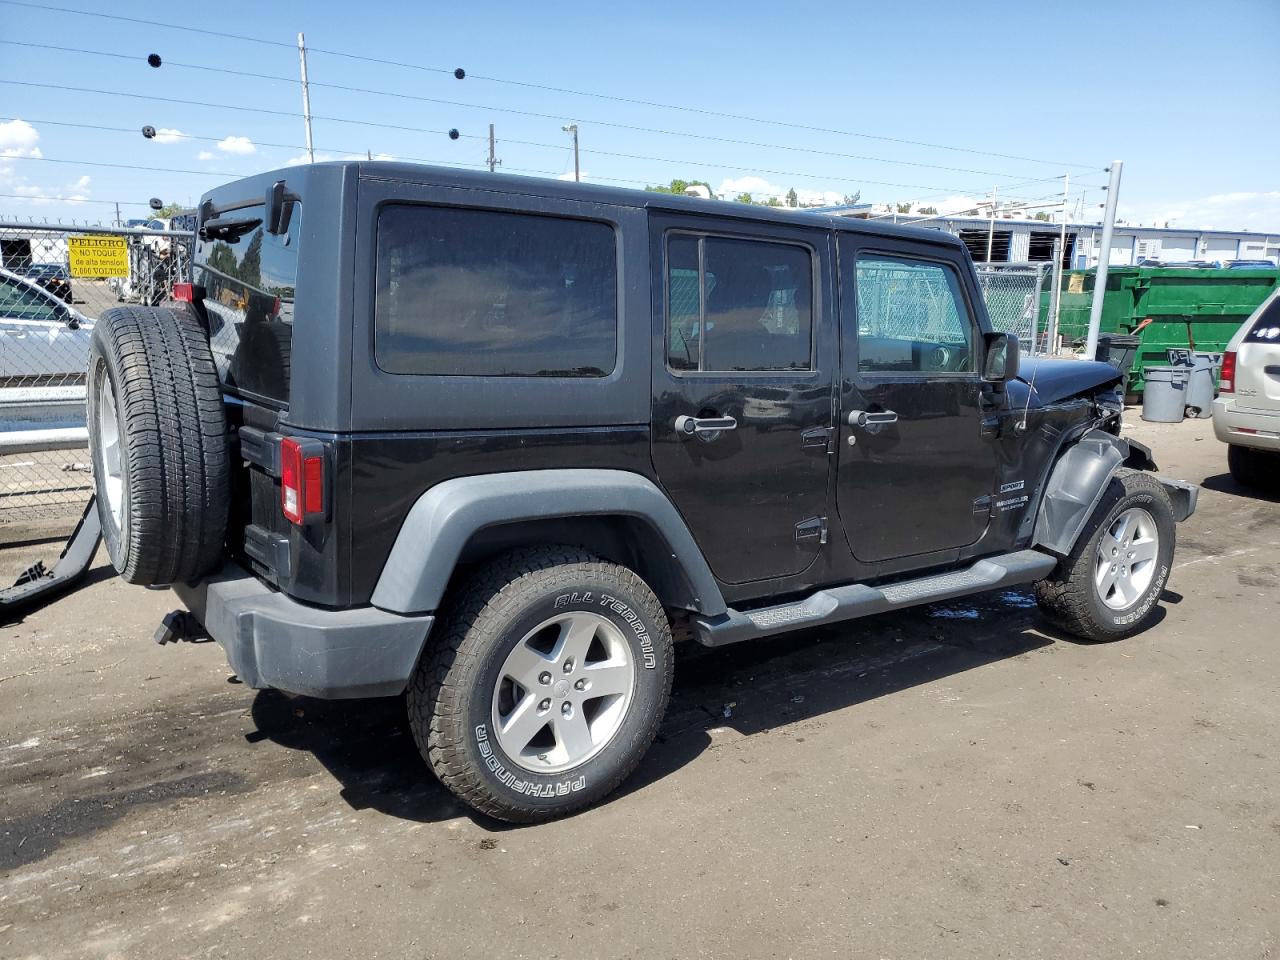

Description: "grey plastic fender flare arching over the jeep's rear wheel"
372 470 727 616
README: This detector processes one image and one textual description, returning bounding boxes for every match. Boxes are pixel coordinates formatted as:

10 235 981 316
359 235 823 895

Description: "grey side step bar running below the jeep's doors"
694 550 1057 646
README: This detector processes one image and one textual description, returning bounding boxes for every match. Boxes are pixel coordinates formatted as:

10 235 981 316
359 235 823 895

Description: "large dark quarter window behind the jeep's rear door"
374 204 618 376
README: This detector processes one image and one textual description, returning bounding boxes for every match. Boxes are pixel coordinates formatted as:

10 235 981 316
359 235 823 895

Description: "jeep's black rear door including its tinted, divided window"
650 216 836 584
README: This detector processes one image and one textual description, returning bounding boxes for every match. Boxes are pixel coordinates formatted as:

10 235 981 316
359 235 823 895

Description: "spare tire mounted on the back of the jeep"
88 306 230 585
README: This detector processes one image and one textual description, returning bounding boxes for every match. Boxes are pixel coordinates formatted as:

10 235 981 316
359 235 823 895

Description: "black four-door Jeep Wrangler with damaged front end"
88 163 1197 820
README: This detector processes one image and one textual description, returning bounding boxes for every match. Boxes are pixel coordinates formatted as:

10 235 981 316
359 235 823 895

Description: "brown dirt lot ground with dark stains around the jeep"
0 415 1280 960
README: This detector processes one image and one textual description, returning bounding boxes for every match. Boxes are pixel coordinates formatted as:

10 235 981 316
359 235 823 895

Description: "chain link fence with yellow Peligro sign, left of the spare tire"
0 223 193 543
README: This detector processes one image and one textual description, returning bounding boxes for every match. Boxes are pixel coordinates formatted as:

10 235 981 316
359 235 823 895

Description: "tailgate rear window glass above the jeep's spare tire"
193 204 302 403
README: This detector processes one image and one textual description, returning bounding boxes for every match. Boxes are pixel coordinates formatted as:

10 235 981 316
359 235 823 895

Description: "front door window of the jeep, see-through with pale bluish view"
855 253 974 372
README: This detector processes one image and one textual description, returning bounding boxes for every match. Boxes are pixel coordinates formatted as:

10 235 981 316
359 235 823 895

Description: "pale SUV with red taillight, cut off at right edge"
1213 288 1280 486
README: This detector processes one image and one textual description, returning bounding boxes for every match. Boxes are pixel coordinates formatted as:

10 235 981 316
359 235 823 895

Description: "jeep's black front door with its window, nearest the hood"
837 236 996 563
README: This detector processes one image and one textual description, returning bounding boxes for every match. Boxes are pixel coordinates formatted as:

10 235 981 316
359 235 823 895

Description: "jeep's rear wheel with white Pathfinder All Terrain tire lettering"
408 547 672 823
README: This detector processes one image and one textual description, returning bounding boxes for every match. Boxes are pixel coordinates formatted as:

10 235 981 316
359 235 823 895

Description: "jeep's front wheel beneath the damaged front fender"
1036 470 1176 641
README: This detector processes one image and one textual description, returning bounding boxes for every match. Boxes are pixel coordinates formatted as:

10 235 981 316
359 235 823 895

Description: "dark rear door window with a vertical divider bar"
667 234 813 371
